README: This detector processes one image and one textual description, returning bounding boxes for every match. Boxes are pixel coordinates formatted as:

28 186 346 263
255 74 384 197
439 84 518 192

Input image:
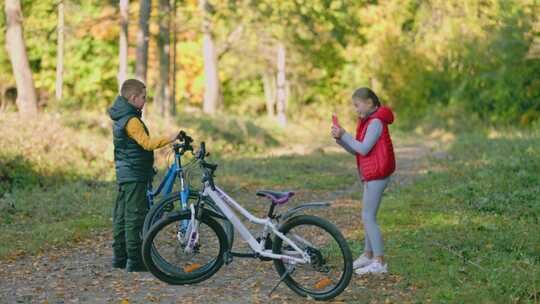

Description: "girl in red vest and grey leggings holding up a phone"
332 88 396 275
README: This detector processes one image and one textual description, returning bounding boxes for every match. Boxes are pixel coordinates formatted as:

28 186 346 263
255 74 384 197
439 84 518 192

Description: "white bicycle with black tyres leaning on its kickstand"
142 142 353 300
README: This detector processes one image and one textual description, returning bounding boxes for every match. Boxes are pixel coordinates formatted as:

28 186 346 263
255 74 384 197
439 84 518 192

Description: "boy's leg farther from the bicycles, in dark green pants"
112 186 127 268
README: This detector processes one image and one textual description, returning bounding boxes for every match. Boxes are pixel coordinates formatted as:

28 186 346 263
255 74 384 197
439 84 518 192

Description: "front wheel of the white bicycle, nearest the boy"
142 211 227 285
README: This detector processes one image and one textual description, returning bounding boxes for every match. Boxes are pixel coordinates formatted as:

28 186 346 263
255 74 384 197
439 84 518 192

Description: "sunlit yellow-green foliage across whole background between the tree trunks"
0 0 540 124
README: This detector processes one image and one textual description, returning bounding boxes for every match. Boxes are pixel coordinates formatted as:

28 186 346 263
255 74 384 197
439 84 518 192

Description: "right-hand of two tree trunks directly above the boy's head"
135 0 152 84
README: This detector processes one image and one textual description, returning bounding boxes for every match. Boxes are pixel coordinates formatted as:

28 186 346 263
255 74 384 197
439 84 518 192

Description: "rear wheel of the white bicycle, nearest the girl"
272 215 353 300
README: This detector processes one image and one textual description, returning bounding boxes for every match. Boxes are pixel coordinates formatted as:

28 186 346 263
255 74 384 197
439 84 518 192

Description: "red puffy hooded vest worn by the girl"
356 106 396 181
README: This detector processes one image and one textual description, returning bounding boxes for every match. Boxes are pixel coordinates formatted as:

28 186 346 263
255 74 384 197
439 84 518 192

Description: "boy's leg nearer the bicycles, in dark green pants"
125 182 148 271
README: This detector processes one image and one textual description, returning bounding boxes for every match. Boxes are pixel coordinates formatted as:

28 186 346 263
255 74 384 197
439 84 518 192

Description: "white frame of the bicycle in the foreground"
202 182 311 264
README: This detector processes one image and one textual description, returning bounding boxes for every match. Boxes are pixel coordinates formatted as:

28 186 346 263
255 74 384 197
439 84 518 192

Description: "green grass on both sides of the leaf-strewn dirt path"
0 113 540 303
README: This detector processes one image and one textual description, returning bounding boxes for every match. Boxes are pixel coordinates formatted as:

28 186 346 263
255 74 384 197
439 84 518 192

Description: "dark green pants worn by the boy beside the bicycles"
113 182 148 263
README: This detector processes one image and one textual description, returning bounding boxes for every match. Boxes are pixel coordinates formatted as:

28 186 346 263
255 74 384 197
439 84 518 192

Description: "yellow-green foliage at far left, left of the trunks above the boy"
0 0 118 109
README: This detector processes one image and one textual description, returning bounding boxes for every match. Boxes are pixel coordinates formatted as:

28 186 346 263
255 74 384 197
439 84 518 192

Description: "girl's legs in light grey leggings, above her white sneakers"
362 178 389 263
